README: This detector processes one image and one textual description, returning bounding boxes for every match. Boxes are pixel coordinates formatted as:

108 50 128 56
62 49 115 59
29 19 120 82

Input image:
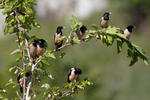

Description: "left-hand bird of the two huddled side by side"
29 40 38 60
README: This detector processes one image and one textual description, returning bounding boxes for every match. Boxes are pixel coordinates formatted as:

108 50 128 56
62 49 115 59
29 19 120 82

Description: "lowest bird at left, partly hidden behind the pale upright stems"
17 71 32 93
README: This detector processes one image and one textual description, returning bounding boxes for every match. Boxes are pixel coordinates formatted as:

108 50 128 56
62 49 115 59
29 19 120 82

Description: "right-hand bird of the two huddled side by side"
36 39 46 57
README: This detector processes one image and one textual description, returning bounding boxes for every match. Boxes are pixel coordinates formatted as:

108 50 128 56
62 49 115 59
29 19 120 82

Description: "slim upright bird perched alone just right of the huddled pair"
54 26 63 50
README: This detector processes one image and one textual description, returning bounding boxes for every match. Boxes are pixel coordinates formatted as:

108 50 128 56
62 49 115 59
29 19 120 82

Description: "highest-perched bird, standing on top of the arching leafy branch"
100 12 111 28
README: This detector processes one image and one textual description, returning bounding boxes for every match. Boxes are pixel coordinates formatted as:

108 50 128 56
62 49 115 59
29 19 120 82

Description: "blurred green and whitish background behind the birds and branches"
0 0 150 100
